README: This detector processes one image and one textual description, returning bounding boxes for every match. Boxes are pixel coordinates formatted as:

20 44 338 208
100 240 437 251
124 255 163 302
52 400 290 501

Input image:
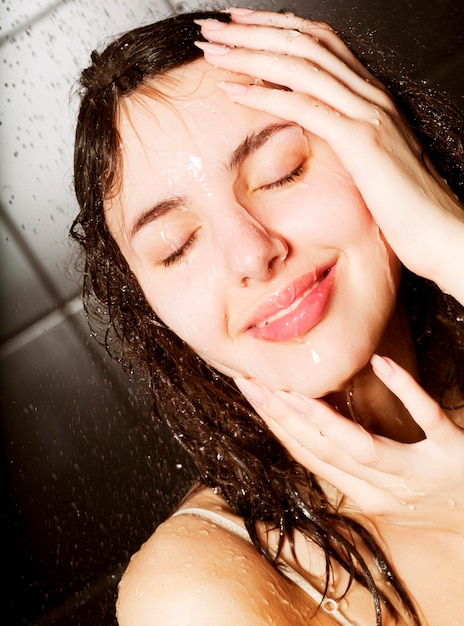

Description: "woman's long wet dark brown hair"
71 6 464 624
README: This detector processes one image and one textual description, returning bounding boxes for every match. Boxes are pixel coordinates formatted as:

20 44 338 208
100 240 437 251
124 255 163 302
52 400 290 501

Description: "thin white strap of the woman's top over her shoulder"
173 507 355 626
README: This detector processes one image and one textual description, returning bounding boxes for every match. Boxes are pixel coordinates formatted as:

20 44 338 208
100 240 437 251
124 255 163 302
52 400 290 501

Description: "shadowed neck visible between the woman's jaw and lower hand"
326 302 423 443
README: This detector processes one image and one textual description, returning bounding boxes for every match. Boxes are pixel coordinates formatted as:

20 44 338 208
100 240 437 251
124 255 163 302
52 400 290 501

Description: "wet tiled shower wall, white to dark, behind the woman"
0 0 464 626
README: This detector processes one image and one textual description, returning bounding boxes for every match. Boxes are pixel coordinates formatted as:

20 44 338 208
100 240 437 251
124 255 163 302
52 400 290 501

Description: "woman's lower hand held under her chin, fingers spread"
236 355 464 534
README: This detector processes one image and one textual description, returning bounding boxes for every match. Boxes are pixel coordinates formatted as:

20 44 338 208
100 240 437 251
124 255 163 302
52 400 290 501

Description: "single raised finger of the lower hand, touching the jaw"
371 354 457 443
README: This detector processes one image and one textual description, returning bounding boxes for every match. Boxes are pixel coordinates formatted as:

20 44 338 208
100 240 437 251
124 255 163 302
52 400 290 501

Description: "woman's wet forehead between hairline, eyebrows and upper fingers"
105 59 280 239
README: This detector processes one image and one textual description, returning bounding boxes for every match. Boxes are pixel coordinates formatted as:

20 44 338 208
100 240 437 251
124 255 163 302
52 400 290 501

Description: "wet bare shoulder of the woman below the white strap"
117 488 322 626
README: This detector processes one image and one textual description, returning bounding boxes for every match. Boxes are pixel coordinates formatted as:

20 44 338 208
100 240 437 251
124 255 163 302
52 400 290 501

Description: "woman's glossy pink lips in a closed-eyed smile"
246 265 335 341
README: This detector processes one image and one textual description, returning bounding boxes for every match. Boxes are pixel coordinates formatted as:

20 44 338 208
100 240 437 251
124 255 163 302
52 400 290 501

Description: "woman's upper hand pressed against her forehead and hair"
198 9 464 303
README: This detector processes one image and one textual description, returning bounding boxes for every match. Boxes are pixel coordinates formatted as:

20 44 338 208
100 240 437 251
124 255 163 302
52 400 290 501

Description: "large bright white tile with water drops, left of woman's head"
0 0 170 297
